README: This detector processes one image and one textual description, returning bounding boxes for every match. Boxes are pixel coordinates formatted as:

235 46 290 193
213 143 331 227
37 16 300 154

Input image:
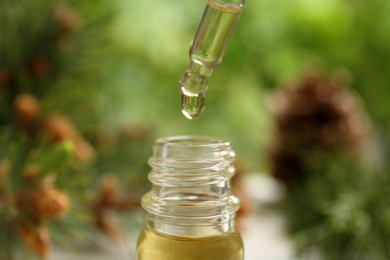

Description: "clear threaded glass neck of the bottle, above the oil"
142 137 240 238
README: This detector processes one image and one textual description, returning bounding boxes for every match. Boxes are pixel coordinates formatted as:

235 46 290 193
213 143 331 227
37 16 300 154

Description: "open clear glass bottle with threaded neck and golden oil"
137 136 244 260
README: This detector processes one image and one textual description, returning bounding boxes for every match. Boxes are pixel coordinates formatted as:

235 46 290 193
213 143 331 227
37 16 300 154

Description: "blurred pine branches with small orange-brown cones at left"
0 0 152 259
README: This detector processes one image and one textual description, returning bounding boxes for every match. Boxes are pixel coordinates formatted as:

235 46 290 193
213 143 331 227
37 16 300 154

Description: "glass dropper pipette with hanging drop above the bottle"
180 0 245 119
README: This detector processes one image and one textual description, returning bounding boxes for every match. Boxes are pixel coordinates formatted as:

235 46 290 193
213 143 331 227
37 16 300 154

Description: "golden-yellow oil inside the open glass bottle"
137 229 244 260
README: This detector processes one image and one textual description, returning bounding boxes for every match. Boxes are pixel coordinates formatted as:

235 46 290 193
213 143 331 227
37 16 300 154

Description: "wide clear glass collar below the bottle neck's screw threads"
142 185 239 237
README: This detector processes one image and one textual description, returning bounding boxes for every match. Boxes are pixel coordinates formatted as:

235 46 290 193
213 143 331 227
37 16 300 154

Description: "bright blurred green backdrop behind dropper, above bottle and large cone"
83 0 390 169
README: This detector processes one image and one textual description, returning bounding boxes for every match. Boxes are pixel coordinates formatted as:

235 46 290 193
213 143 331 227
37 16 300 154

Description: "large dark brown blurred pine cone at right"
270 71 370 186
